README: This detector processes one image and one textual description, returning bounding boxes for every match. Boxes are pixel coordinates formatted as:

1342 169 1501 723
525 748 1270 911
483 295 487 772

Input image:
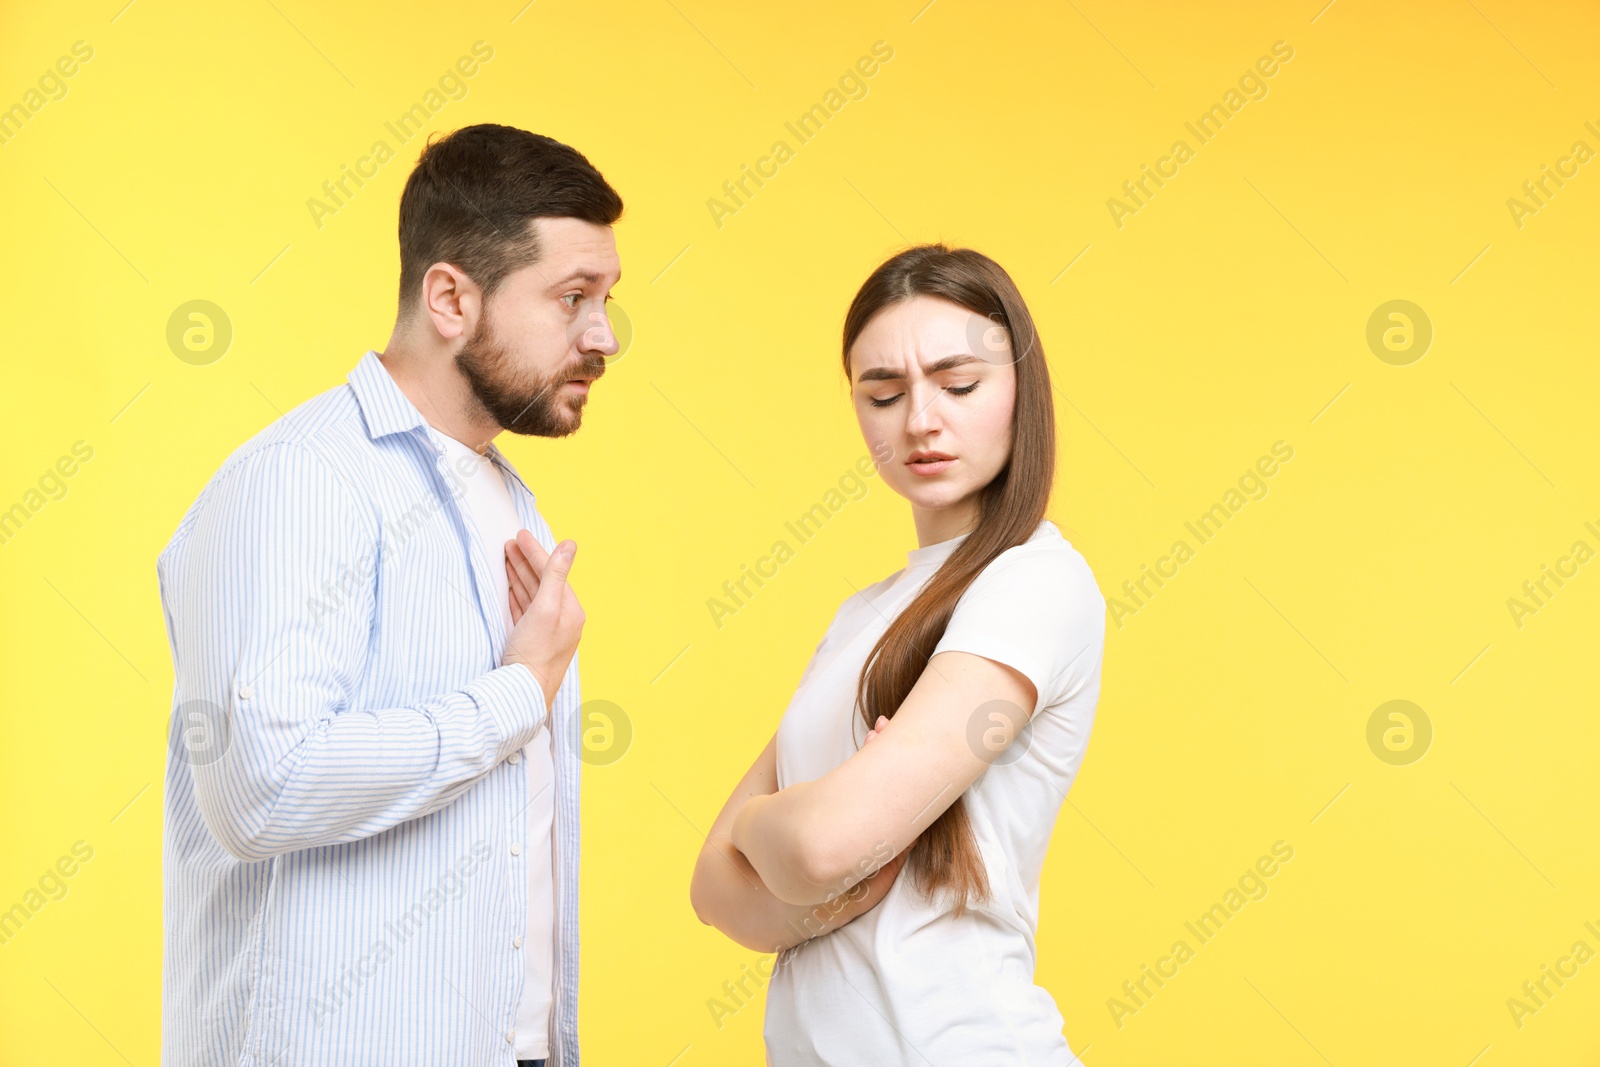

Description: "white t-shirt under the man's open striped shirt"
432 430 555 1059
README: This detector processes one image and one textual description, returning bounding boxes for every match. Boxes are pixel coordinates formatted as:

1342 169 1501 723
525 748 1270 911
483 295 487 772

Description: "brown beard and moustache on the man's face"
456 315 606 437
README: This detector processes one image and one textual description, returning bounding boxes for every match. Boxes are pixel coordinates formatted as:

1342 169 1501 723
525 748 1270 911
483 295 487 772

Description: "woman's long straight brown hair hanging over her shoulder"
843 245 1056 915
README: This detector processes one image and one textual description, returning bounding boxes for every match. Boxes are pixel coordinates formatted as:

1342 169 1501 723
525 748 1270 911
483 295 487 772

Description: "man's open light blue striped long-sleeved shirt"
157 352 581 1067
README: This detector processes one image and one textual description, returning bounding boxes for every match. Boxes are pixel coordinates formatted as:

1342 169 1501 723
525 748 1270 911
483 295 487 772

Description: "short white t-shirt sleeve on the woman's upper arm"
933 544 1106 713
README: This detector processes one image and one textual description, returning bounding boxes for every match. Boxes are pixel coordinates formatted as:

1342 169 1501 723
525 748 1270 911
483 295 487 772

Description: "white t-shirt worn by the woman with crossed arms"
763 520 1106 1067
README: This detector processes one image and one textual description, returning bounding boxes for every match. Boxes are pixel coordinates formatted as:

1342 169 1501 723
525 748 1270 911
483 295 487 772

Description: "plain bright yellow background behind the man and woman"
0 0 1600 1067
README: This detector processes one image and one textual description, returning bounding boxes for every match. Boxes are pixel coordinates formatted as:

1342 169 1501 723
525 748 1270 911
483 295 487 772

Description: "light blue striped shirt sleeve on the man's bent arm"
162 442 547 861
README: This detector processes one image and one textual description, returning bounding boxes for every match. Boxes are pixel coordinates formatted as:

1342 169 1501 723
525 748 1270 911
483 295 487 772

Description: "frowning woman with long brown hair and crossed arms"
690 245 1106 1067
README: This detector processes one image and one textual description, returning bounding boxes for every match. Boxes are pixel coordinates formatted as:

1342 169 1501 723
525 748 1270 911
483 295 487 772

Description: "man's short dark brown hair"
400 123 622 322
